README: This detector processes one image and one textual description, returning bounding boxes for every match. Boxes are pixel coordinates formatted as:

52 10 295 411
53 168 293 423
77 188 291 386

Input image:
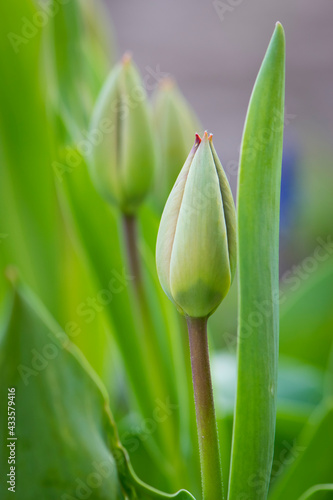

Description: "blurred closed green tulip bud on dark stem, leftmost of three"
89 55 155 214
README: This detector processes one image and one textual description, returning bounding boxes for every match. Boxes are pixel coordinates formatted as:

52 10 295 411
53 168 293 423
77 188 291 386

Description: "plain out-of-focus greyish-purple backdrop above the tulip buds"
107 0 333 169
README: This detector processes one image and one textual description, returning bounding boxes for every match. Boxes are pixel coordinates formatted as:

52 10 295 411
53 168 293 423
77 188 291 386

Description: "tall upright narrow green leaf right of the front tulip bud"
229 23 285 500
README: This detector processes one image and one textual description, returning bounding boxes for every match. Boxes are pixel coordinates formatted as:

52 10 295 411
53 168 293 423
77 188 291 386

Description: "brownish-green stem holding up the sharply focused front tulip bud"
187 317 224 500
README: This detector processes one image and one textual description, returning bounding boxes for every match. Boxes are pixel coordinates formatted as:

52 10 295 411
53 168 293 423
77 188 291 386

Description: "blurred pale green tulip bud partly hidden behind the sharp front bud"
153 78 201 212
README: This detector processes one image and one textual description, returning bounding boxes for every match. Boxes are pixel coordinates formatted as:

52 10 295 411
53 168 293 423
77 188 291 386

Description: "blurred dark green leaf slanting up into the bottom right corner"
269 405 333 500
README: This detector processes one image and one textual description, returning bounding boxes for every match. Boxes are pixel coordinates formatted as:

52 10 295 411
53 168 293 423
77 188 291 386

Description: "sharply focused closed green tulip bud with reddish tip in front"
156 132 236 318
